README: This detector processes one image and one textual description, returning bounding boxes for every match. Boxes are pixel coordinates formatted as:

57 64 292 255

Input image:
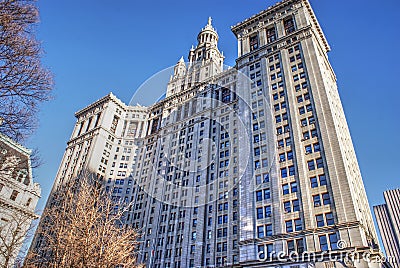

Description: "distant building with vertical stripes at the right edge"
374 189 400 268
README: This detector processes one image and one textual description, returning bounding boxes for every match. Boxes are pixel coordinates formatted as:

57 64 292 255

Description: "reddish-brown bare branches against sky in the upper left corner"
0 0 53 141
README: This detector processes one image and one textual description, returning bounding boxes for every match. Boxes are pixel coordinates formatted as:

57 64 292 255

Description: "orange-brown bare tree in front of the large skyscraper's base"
26 173 139 268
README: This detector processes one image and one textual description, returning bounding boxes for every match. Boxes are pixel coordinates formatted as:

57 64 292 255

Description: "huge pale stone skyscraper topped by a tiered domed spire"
34 0 379 268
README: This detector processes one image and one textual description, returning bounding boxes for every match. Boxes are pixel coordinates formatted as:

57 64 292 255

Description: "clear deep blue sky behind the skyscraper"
27 0 400 215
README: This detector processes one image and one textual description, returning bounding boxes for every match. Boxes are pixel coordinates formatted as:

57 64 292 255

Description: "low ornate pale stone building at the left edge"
0 134 40 267
